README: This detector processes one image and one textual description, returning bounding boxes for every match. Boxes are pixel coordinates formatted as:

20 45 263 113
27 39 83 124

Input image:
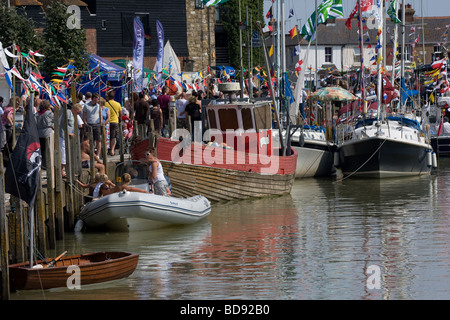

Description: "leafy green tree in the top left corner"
0 5 43 53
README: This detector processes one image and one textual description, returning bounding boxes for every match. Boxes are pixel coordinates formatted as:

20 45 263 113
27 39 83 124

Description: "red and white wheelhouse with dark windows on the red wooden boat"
206 101 273 154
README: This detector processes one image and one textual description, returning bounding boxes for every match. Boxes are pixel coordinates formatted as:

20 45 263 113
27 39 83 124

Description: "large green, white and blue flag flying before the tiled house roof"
300 0 344 41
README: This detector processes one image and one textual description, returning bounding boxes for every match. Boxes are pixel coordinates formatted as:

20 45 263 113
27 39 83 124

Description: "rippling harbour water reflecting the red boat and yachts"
11 159 450 300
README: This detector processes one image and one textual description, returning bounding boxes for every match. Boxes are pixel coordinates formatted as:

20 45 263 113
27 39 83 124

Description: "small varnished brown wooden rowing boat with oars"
9 252 139 290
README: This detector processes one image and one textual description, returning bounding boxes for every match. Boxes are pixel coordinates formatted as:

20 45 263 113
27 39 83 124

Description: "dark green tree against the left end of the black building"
43 1 87 76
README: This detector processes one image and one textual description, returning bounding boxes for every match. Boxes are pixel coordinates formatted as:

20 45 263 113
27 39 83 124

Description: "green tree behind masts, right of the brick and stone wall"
220 0 264 69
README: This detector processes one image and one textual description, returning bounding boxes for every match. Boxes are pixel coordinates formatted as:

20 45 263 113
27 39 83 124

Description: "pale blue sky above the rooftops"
264 0 450 30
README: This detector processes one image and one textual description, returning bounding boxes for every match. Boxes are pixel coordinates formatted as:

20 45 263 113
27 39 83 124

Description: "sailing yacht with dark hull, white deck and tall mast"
337 0 433 178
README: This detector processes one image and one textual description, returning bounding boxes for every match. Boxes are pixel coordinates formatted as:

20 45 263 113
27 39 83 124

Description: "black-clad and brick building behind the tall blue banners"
2 0 216 71
